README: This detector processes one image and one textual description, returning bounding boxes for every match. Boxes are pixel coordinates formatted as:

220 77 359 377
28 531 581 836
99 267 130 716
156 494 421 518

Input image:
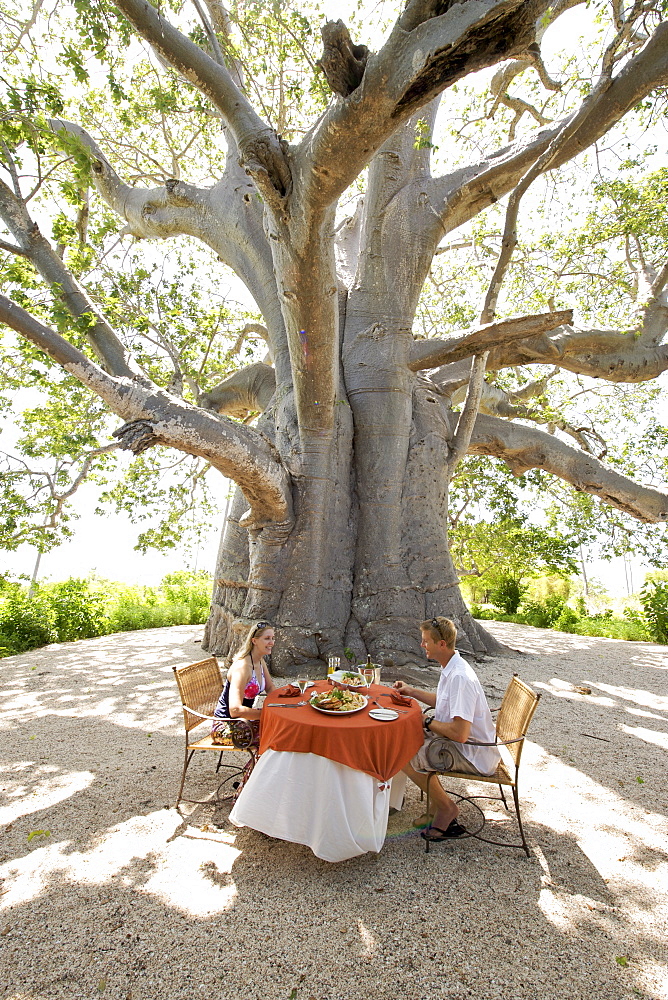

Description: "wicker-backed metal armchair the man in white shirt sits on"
426 674 540 856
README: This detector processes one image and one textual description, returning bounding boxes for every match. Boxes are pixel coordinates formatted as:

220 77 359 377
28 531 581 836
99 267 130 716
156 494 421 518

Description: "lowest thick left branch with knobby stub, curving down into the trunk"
0 295 292 530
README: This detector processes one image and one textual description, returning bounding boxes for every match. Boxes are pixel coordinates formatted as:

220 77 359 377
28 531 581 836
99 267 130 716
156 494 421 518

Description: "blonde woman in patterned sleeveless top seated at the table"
212 622 275 733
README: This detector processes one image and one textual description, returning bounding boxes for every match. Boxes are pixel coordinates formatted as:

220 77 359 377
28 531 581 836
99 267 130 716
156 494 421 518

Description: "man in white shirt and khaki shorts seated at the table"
394 617 501 842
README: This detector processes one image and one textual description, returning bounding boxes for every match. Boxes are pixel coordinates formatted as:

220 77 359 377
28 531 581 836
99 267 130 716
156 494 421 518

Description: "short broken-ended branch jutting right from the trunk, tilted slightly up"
408 309 573 372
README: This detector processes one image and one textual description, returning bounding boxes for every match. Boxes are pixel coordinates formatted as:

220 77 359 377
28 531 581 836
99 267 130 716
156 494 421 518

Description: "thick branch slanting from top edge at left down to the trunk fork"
116 0 292 208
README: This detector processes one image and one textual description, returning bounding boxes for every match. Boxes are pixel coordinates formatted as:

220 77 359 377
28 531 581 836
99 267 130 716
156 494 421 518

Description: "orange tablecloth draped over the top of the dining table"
260 681 424 781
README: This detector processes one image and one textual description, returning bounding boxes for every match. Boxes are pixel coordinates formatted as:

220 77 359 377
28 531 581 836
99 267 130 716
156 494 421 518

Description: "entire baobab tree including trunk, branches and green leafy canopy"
0 0 668 663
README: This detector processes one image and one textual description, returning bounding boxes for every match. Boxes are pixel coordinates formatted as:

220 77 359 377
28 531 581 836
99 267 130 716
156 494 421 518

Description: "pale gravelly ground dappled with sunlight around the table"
0 623 668 1000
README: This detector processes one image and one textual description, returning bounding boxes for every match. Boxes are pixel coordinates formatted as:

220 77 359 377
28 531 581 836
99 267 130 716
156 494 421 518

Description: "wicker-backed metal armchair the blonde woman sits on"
173 656 257 809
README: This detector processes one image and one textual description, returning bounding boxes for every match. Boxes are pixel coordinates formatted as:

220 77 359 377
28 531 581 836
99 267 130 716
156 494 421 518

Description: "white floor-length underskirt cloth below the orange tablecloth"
230 750 406 861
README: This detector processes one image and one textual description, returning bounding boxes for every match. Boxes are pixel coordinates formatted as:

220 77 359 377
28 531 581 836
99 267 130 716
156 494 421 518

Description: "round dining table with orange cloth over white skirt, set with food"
230 680 424 862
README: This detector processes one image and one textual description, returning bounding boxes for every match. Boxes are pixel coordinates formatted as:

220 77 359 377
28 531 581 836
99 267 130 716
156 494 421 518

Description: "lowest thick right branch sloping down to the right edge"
469 415 668 524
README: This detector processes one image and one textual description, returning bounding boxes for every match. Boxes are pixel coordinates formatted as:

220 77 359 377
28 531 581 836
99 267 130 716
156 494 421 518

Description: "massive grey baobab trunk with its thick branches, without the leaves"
0 0 668 670
